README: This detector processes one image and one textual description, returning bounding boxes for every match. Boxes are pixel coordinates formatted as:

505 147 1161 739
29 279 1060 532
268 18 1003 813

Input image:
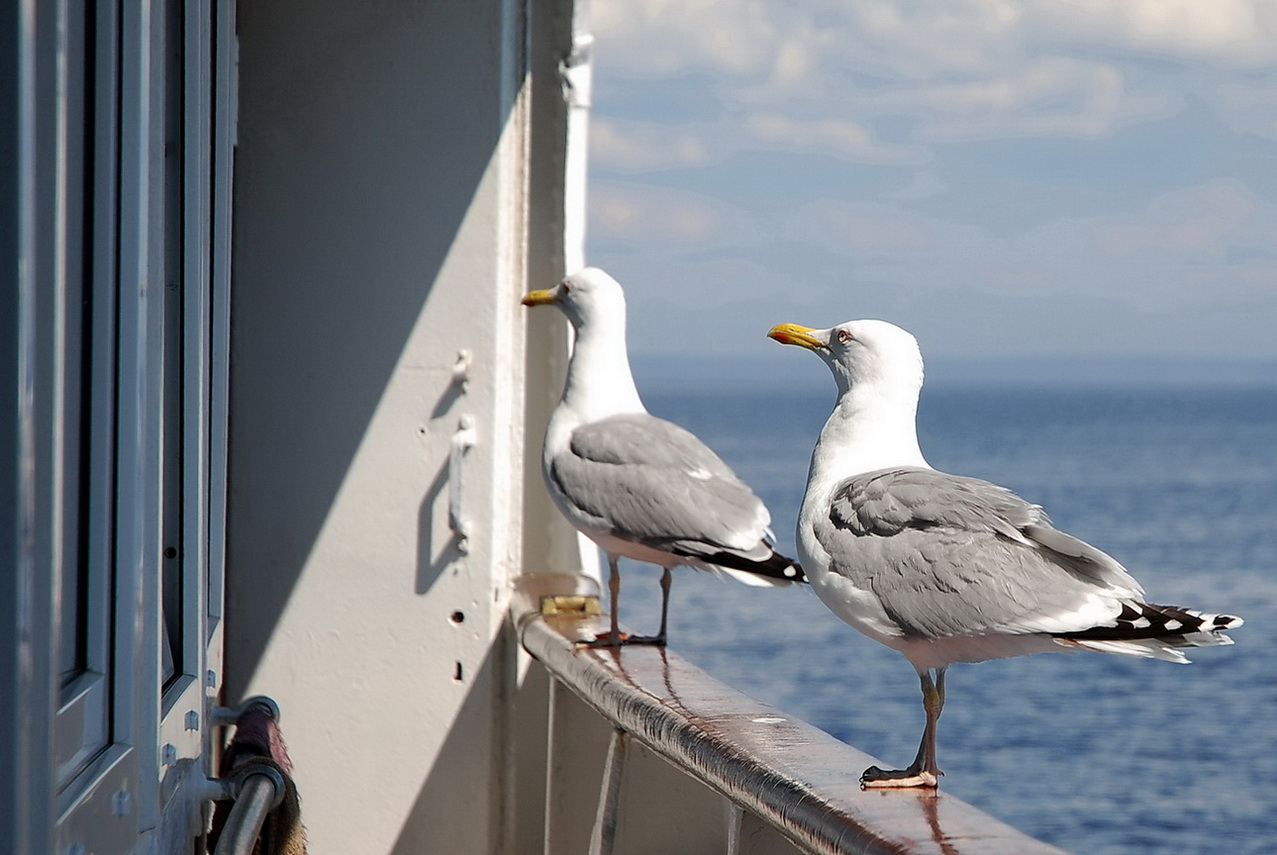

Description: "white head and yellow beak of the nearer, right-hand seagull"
767 320 922 401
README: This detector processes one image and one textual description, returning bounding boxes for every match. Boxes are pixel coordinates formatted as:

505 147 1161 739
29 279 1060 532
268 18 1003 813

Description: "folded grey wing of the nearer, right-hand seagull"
816 468 1140 637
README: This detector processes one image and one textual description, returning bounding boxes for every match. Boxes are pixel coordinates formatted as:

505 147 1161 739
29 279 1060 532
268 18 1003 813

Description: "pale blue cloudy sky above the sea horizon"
587 0 1277 377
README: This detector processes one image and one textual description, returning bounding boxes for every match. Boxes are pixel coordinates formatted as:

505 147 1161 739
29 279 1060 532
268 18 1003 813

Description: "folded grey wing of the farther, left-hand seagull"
549 413 769 560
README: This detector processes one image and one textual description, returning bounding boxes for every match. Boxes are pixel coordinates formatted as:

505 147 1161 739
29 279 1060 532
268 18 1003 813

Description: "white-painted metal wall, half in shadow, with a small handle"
225 0 576 854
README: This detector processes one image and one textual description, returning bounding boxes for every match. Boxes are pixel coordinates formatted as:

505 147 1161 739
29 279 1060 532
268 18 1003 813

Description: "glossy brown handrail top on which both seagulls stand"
513 574 1062 855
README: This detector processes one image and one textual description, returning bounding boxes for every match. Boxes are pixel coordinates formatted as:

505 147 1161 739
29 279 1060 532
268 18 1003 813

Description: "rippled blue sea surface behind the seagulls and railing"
621 387 1277 855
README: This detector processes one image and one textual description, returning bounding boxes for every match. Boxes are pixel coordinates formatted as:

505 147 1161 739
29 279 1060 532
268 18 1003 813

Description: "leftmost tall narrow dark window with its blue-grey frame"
54 4 117 792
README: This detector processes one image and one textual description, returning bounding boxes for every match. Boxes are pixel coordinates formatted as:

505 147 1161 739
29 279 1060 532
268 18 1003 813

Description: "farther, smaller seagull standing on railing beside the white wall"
524 267 805 646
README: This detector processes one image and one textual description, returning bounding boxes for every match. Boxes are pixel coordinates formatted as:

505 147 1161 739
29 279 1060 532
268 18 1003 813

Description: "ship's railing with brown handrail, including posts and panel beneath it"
515 576 1062 855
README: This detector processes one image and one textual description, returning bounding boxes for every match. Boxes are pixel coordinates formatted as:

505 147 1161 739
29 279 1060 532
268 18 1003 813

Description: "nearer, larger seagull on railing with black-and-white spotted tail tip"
767 320 1241 787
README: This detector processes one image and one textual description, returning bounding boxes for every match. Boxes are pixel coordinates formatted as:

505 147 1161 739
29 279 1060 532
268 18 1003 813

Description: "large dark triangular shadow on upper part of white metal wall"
226 0 507 698
